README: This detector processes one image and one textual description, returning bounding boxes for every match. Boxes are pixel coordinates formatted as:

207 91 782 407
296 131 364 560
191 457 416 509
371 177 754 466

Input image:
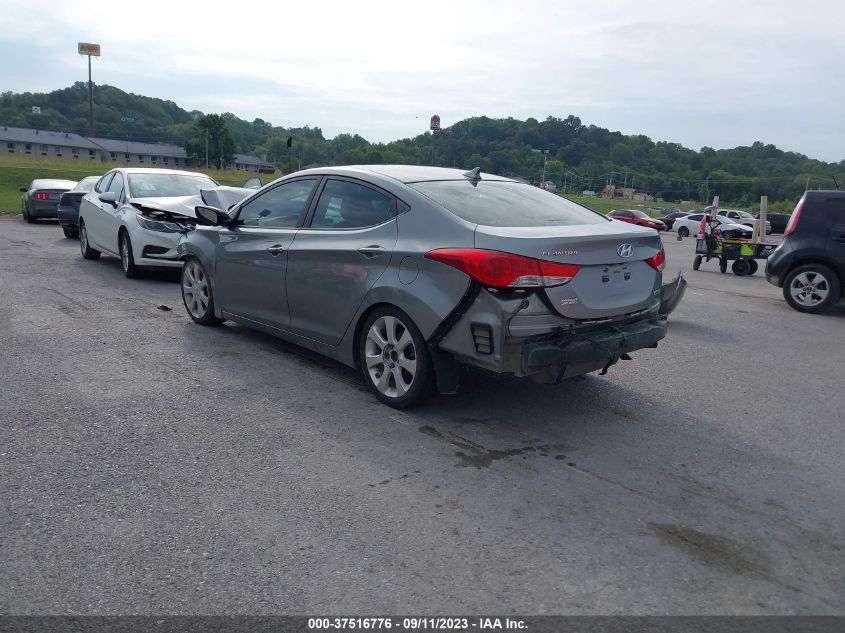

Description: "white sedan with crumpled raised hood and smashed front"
79 167 251 277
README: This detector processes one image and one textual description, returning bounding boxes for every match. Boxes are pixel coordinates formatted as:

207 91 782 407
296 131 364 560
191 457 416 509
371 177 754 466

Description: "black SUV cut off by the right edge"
766 191 845 313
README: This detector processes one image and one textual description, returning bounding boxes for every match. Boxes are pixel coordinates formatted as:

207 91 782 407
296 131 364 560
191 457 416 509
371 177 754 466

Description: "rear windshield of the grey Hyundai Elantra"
408 180 610 226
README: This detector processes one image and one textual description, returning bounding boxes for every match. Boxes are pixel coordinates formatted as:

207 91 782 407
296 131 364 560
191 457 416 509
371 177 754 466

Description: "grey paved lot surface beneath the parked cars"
0 217 845 614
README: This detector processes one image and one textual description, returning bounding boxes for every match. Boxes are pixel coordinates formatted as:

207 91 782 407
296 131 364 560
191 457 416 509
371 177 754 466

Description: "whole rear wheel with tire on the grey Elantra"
358 306 435 409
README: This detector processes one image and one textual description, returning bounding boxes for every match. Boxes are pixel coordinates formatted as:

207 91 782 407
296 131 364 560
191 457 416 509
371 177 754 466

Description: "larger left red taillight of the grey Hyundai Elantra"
425 248 581 288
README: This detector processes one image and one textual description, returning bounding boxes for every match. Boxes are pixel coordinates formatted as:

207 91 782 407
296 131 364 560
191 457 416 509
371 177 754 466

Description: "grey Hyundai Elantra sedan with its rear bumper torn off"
179 165 685 408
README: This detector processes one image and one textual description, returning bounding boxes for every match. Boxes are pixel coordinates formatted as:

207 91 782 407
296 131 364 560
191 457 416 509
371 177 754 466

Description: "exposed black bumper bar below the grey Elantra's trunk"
522 315 667 375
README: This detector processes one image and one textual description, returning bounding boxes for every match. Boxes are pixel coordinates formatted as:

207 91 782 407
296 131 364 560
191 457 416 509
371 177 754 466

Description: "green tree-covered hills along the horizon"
0 82 845 208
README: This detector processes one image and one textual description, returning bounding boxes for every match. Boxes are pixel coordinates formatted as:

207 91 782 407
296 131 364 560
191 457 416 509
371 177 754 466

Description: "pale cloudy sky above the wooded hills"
0 0 845 162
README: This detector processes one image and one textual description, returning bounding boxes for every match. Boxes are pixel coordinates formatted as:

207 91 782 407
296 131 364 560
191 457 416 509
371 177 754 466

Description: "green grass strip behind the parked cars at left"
0 156 274 213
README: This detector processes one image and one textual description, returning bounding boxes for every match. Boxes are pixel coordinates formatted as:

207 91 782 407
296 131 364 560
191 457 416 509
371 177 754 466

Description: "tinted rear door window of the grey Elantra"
311 180 393 229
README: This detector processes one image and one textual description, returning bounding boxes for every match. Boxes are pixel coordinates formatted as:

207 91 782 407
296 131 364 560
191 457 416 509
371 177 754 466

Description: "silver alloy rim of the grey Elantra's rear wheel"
364 316 418 398
